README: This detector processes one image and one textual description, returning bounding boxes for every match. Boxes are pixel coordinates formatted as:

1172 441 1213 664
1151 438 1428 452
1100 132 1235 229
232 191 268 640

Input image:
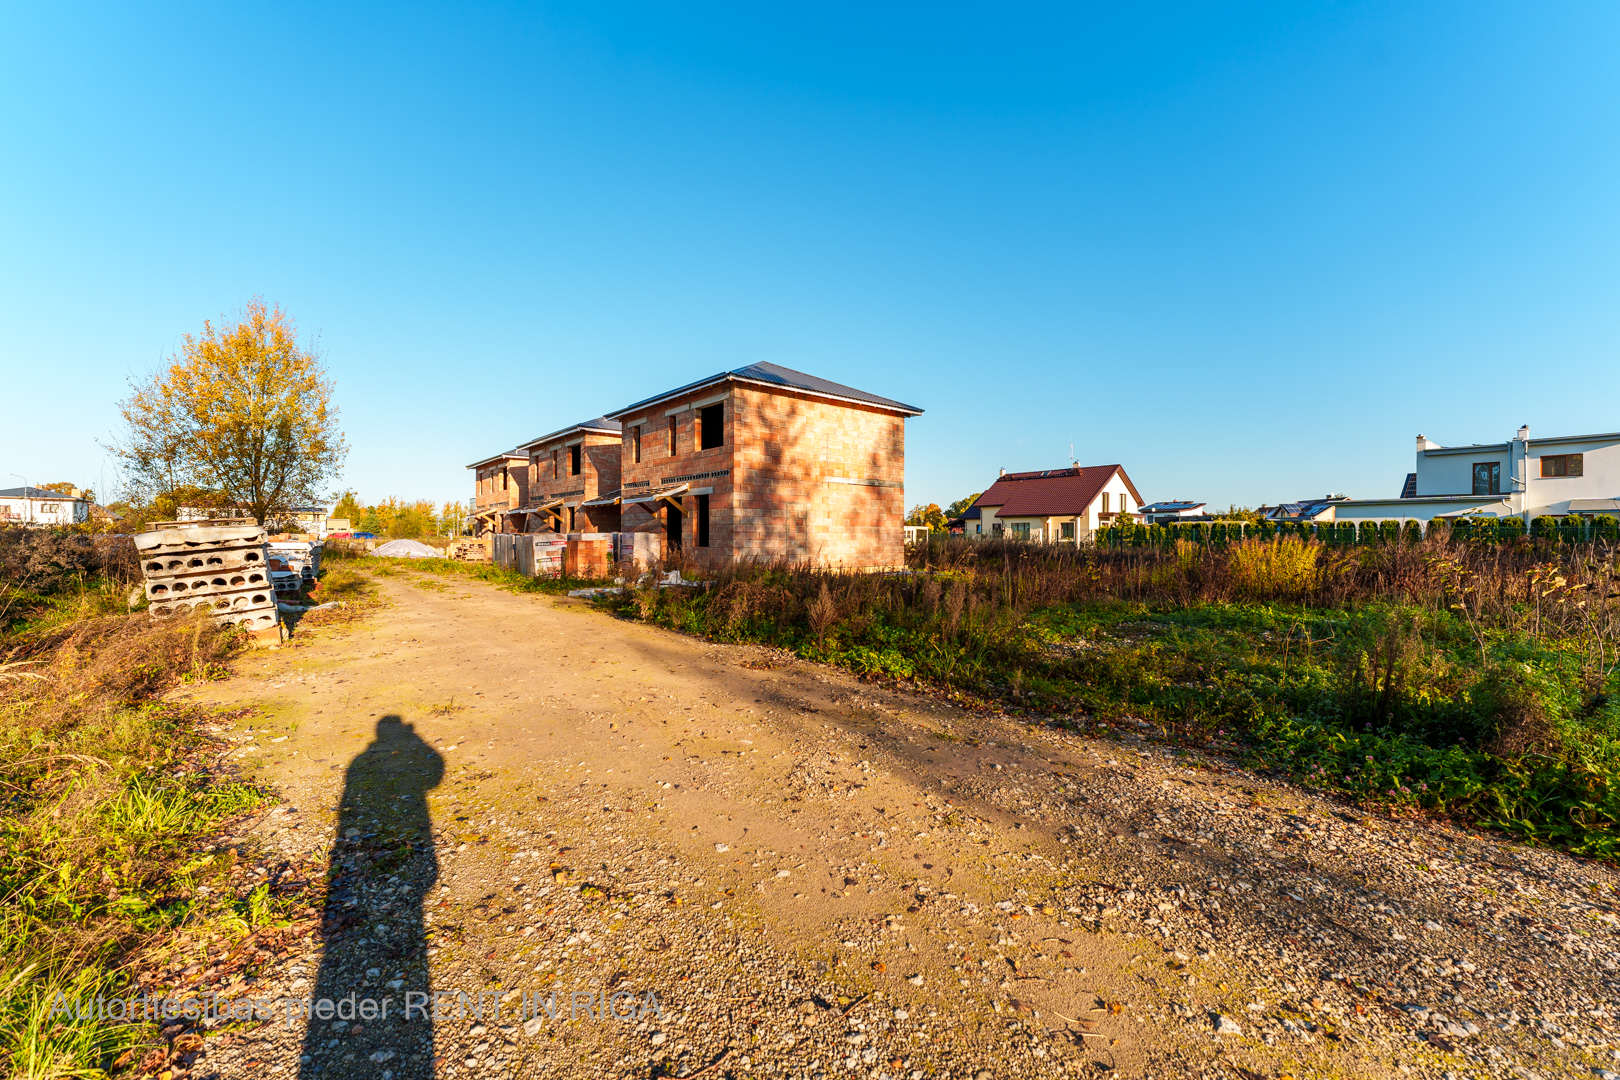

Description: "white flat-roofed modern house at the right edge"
1333 426 1620 521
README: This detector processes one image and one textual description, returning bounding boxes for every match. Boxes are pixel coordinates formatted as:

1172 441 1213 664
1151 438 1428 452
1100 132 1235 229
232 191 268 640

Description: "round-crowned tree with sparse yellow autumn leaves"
112 298 348 523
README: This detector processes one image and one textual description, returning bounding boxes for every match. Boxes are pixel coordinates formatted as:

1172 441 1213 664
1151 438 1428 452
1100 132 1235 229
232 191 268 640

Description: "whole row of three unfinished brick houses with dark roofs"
468 363 922 575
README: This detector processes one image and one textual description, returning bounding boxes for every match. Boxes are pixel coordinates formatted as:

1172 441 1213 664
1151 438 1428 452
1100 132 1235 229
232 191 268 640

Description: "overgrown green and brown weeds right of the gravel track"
601 536 1620 860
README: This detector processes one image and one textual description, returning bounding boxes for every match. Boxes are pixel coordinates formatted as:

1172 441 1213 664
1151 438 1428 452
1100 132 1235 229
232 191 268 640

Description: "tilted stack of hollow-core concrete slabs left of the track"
134 523 277 630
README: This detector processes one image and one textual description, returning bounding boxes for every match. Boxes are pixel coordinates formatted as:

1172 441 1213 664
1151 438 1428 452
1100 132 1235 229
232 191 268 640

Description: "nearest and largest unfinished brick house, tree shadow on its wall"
603 364 922 570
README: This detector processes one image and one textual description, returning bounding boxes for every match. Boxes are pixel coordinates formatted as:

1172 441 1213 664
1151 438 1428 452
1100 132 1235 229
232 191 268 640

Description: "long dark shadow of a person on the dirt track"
298 716 444 1080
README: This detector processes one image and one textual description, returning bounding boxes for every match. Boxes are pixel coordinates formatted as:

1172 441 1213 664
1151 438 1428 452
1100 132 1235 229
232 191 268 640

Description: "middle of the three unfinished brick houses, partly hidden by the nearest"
514 416 620 533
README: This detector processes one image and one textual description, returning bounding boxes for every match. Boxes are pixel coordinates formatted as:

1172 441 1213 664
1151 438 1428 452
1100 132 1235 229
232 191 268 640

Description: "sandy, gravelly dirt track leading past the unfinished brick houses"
174 575 1620 1080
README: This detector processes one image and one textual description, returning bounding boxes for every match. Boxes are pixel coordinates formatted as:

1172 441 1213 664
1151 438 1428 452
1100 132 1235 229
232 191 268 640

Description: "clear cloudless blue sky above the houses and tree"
0 2 1620 505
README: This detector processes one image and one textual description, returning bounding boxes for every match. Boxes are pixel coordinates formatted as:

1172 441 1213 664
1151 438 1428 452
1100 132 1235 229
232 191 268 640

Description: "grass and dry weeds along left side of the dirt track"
0 614 277 1078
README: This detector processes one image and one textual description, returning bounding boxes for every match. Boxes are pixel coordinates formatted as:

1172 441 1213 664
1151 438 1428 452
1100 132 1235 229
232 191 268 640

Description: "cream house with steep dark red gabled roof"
961 465 1142 544
